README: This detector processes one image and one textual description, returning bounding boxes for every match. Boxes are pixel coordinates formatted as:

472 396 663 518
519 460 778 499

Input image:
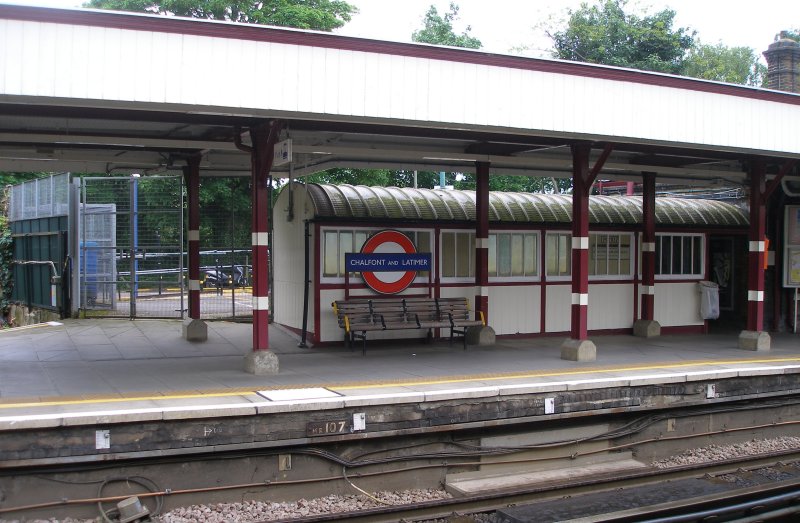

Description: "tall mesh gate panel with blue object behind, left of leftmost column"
79 176 186 318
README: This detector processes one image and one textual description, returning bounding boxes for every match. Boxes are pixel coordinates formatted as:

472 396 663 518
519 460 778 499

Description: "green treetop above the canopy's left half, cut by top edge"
84 0 358 31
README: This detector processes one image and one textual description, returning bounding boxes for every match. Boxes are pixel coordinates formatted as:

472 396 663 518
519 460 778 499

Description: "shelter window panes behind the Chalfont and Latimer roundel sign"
321 229 431 278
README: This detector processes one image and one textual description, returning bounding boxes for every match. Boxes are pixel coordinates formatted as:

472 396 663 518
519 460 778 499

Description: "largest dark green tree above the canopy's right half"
548 0 695 74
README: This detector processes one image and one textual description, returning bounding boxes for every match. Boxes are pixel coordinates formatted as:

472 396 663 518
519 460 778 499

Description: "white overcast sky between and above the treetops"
6 0 800 62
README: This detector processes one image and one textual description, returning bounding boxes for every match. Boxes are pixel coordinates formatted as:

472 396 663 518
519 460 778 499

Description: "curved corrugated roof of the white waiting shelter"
307 184 748 227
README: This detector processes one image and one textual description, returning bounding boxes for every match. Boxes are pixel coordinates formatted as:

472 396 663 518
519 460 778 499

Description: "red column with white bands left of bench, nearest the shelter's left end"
245 121 281 374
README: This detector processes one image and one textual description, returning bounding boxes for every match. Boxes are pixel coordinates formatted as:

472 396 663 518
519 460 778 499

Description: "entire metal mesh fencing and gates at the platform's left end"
9 174 256 320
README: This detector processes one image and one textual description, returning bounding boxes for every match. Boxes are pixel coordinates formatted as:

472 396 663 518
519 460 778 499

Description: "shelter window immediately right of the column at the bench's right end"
489 232 539 278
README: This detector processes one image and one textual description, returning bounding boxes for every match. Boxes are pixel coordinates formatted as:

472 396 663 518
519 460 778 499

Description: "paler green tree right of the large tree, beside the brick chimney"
681 42 767 87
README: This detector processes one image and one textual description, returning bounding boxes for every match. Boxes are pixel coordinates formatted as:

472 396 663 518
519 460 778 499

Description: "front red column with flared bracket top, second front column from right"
561 144 596 361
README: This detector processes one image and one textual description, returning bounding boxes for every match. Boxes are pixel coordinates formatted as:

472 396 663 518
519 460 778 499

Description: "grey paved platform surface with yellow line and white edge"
0 319 800 423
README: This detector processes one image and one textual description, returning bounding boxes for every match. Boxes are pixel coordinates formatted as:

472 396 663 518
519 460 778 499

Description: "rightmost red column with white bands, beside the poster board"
739 158 771 350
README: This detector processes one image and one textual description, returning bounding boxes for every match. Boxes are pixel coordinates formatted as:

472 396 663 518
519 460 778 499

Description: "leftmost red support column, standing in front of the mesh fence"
183 156 208 341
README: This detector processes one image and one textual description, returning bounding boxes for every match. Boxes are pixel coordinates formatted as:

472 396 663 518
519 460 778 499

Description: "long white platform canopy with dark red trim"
0 5 800 184
